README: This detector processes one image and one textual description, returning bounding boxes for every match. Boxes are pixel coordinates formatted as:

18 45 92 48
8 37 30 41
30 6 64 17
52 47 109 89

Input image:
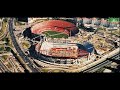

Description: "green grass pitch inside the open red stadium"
44 31 68 38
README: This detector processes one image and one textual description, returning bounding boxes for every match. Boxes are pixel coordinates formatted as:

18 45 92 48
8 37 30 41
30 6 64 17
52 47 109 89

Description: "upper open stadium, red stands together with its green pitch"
31 20 79 38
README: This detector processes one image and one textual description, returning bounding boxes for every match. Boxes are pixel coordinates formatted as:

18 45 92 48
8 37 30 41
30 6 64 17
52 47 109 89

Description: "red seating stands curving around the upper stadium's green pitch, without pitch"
31 20 77 35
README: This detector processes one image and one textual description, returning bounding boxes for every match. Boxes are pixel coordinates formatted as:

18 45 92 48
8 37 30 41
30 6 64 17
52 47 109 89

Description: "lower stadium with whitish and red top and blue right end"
35 41 93 58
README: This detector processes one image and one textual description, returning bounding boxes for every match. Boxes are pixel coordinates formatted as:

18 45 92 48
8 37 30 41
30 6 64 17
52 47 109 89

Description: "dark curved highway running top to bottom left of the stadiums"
8 19 39 72
